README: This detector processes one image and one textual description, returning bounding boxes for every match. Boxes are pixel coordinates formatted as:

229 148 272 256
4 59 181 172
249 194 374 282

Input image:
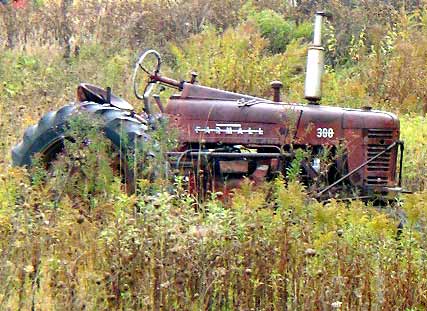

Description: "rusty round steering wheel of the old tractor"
132 50 162 100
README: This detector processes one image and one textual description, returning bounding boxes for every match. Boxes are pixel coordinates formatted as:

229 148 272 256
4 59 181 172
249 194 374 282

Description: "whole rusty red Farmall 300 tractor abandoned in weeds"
12 12 404 200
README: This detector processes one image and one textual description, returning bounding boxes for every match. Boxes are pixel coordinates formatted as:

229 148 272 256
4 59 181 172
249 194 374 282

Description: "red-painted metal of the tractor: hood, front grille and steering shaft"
155 75 399 199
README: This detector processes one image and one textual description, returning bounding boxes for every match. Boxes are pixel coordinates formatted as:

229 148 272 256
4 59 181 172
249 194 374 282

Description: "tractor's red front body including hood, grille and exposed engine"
165 83 399 200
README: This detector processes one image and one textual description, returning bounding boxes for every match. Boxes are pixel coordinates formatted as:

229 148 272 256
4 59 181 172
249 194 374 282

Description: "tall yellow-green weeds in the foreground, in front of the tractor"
0 160 427 310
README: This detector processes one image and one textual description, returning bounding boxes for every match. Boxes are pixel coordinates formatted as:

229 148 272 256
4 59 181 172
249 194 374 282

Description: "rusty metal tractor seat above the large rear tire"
77 83 134 110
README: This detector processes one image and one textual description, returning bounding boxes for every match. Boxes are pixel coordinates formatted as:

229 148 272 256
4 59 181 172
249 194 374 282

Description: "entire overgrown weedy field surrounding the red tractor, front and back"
0 0 427 310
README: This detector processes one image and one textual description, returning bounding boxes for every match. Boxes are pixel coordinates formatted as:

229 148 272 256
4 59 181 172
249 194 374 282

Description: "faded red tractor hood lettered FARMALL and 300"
165 83 399 145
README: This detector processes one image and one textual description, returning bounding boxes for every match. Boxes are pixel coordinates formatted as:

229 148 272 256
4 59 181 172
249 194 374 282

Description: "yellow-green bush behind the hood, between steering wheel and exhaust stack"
171 22 305 99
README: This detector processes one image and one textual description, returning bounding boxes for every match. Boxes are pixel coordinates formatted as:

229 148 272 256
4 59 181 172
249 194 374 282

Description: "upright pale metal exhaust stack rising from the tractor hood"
304 12 331 104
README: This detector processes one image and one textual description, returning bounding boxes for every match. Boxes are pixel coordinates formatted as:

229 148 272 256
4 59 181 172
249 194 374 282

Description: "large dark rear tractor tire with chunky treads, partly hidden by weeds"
12 102 150 192
